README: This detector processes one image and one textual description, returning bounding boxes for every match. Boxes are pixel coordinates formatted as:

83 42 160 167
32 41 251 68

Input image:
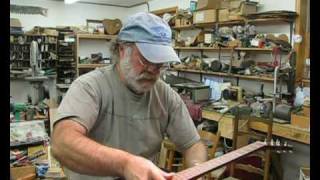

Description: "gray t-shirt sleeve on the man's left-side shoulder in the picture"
53 77 100 131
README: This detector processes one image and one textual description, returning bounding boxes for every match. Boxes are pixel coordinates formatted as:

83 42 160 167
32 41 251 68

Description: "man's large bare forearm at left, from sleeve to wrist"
52 121 132 176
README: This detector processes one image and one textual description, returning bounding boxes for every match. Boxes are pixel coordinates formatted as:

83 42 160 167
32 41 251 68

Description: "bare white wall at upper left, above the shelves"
10 0 127 31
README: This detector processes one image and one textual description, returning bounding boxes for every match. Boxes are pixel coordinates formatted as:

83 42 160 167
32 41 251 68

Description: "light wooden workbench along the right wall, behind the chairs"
202 109 310 144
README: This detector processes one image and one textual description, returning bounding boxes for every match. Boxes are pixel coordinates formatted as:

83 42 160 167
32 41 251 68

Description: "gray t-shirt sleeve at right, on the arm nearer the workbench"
167 87 200 152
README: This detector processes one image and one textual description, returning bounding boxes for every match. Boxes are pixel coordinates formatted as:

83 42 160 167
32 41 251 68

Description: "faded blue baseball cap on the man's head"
118 12 180 63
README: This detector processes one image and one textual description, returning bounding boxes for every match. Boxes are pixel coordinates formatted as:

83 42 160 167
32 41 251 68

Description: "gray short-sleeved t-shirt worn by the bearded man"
54 65 200 180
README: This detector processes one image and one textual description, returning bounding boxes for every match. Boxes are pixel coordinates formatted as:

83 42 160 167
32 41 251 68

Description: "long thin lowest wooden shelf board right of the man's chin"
171 68 273 82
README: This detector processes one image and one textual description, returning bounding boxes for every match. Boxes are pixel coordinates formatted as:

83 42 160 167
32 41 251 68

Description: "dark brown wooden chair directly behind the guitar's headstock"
230 106 273 180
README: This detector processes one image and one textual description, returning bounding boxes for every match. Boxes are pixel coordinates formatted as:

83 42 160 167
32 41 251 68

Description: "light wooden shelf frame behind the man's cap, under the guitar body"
76 34 117 76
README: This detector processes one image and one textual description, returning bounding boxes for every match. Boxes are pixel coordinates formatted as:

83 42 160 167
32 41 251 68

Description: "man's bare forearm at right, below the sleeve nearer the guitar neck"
184 141 208 167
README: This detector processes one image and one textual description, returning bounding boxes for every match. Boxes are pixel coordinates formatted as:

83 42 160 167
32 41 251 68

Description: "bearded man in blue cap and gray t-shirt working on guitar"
52 13 207 180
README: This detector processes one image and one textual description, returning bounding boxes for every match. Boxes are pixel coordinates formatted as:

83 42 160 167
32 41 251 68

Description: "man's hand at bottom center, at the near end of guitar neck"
123 156 174 180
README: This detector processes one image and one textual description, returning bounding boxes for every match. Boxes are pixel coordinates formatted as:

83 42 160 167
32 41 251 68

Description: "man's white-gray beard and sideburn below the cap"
119 47 159 94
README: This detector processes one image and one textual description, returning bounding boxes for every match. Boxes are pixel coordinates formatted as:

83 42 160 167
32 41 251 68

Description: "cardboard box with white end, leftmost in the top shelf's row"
193 9 217 24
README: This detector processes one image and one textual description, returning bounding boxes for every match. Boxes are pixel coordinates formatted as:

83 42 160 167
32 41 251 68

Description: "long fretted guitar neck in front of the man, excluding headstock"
174 141 266 180
